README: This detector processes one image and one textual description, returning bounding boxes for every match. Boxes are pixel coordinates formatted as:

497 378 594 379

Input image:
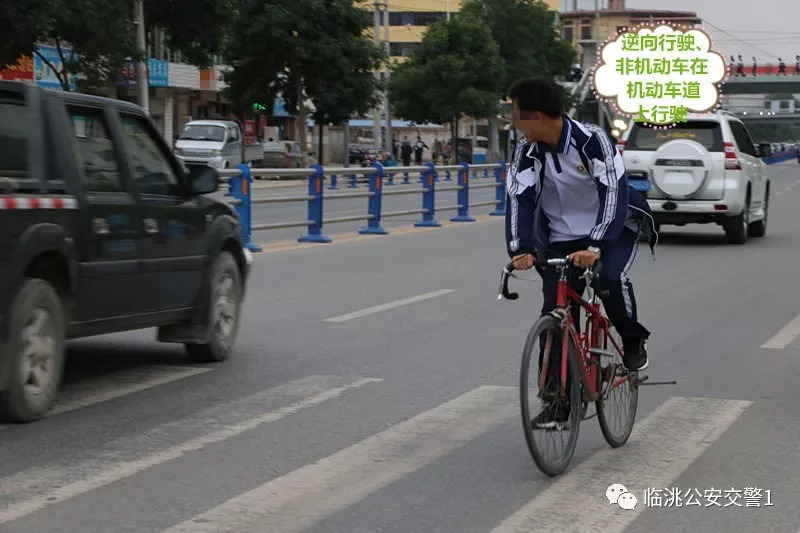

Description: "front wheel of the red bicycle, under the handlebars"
520 315 582 476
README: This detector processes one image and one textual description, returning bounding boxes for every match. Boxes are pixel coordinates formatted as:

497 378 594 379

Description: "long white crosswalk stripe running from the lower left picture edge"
0 376 381 524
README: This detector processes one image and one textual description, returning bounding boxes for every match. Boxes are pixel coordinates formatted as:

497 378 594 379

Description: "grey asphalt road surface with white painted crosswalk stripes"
0 164 800 533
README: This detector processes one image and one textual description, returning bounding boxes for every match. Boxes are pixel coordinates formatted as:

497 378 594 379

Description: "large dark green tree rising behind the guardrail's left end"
226 0 384 164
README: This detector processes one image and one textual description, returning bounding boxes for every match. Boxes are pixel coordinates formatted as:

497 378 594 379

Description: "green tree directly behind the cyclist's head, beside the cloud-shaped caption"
460 0 576 96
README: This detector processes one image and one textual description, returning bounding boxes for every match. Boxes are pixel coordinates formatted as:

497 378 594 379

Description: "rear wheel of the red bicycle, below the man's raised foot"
595 328 639 448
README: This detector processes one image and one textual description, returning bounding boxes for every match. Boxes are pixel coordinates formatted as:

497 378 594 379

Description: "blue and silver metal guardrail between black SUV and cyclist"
219 162 506 252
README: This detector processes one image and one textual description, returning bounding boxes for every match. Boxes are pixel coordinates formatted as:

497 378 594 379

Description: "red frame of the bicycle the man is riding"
539 259 630 402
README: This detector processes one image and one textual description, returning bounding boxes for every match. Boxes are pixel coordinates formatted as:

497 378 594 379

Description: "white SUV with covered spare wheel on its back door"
617 111 770 244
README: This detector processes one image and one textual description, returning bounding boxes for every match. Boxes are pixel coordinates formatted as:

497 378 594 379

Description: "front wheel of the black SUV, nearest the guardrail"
186 252 242 363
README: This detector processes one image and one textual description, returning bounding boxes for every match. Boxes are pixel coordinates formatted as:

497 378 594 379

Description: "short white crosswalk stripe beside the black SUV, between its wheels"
48 366 213 416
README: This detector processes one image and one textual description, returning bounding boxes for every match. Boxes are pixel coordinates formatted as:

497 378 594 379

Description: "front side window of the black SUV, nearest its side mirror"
122 115 181 196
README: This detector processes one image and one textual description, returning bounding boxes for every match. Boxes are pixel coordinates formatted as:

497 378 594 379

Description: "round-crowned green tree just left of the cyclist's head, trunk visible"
389 17 506 158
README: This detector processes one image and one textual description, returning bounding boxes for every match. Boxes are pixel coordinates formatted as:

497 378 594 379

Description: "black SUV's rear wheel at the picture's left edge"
0 279 66 422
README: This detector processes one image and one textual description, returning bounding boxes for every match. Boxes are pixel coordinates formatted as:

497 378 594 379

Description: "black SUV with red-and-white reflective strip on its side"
0 82 252 421
